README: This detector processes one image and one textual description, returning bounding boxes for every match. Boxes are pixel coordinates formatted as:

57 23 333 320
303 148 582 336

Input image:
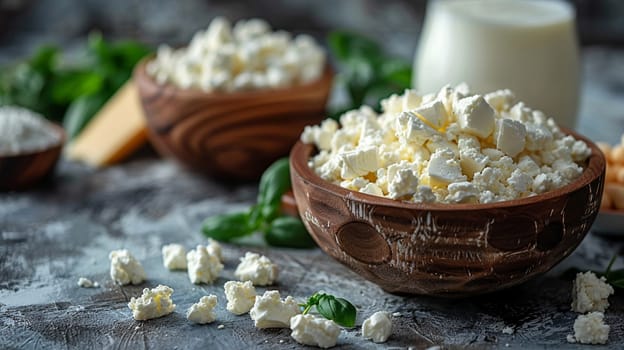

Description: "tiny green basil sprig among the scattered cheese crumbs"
299 292 357 328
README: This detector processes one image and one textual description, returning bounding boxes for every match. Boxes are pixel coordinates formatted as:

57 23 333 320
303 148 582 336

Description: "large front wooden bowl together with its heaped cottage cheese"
290 86 605 297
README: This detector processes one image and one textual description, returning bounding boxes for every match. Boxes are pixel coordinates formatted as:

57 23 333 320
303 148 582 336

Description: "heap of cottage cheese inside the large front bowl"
301 86 591 203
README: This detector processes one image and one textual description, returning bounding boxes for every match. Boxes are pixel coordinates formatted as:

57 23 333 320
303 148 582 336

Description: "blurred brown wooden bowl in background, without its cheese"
134 58 333 180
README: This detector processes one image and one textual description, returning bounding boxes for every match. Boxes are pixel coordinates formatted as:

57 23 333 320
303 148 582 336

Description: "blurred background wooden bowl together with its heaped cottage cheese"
134 18 333 180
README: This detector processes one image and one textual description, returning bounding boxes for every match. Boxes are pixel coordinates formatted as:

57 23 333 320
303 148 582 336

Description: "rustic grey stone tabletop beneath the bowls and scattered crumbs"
0 50 624 349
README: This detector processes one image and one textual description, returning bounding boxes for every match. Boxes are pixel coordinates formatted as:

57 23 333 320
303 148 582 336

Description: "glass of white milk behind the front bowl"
412 0 580 128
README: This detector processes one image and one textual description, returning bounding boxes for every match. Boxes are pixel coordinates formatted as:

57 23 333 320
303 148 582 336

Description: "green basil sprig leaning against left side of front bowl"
202 158 315 248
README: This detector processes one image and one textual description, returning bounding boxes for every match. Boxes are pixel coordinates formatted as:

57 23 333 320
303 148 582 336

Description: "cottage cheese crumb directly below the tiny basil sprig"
290 314 340 349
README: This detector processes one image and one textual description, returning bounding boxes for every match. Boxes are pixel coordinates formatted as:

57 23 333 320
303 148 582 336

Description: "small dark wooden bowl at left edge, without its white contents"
0 125 65 191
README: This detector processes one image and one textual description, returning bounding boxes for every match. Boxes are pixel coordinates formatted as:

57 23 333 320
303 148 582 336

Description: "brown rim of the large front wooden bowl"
290 128 606 212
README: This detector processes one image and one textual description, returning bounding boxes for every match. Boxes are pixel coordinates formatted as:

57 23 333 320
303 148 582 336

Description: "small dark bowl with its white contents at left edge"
0 106 66 191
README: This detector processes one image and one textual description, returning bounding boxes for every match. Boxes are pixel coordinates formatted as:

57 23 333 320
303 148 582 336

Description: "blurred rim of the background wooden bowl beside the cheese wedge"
132 53 334 100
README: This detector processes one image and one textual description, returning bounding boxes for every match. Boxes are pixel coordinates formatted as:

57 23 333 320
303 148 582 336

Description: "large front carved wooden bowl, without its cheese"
290 133 605 297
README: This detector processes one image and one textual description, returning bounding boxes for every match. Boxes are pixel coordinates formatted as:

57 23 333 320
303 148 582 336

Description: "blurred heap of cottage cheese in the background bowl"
147 17 326 92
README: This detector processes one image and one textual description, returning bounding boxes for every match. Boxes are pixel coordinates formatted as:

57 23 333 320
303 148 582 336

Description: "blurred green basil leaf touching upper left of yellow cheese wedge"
63 94 108 139
